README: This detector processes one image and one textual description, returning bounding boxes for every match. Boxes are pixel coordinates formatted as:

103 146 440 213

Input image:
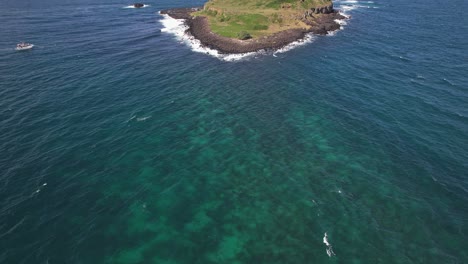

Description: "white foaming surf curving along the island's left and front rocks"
161 14 315 61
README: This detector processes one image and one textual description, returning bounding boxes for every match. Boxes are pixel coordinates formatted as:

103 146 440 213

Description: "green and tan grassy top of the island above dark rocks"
194 0 332 39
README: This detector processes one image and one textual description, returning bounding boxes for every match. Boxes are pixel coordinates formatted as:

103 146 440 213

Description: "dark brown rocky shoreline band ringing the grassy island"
160 7 345 54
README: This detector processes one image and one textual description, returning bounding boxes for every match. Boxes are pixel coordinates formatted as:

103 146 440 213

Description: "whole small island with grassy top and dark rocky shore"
161 0 345 53
